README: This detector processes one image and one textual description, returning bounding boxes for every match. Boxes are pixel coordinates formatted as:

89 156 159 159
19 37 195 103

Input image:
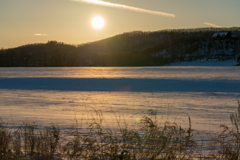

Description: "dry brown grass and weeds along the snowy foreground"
0 102 240 160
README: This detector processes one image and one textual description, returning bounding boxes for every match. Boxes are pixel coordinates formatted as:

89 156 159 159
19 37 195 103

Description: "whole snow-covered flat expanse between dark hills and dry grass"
0 66 240 132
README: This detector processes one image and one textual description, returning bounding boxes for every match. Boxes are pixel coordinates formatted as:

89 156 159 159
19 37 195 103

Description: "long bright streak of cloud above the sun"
72 0 176 17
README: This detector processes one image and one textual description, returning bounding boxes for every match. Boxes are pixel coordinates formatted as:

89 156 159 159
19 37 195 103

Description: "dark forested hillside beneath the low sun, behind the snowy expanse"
0 27 240 67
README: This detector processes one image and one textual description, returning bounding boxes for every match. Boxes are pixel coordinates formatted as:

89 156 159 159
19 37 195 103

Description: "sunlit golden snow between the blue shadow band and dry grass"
0 90 240 131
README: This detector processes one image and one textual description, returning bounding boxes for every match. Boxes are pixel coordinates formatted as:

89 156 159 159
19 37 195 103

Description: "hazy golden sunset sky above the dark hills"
0 0 240 48
